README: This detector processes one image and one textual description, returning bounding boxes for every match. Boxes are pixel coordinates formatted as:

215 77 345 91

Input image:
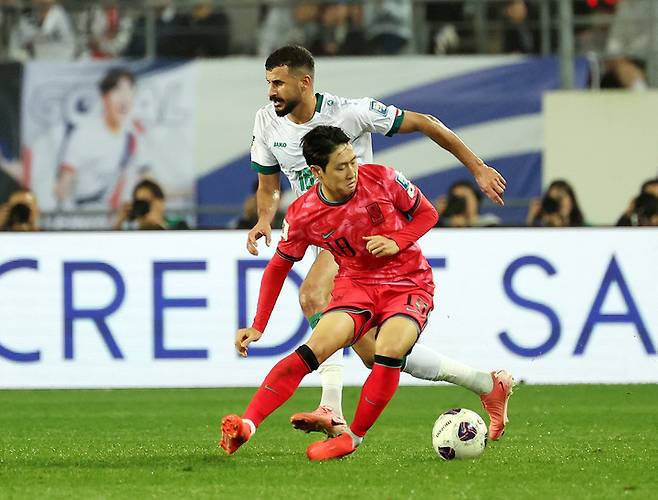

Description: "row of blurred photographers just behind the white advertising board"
0 170 658 231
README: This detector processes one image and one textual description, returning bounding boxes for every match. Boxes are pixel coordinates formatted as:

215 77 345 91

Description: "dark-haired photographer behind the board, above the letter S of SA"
528 180 587 227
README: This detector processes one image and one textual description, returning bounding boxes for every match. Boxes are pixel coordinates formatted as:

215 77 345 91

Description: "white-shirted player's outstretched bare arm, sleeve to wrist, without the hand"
399 111 485 176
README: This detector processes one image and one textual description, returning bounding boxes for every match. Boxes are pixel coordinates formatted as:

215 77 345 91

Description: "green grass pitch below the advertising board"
0 385 658 500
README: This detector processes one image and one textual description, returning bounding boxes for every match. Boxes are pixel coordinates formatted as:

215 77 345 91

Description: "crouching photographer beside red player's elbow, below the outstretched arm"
436 180 500 227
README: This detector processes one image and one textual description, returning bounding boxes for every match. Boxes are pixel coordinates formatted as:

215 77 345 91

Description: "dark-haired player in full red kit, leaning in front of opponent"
220 126 506 460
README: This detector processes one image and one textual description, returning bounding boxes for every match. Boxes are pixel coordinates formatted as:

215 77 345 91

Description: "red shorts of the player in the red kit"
324 278 434 343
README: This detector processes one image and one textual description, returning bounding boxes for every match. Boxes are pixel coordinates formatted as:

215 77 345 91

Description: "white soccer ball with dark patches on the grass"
432 408 487 460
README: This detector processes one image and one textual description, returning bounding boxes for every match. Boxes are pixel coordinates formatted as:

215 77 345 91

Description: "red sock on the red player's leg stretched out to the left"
242 352 311 427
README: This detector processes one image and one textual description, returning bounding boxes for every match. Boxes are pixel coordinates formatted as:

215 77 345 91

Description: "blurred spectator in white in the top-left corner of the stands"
9 0 76 61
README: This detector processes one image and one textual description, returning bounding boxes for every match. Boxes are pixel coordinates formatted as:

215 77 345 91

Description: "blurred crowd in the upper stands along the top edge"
0 0 658 89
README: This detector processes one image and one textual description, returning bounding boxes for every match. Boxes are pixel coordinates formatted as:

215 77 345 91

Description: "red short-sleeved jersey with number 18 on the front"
277 164 434 294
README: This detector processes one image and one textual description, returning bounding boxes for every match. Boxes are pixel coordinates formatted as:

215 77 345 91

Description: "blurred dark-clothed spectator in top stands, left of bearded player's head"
179 0 231 58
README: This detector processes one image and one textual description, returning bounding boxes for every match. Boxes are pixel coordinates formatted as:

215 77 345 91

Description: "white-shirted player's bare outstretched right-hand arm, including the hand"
398 111 507 205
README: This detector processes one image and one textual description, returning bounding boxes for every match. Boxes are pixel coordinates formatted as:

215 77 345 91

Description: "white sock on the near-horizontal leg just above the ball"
403 344 493 395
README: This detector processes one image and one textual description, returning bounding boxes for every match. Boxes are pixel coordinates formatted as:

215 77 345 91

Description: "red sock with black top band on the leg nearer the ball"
350 355 402 437
